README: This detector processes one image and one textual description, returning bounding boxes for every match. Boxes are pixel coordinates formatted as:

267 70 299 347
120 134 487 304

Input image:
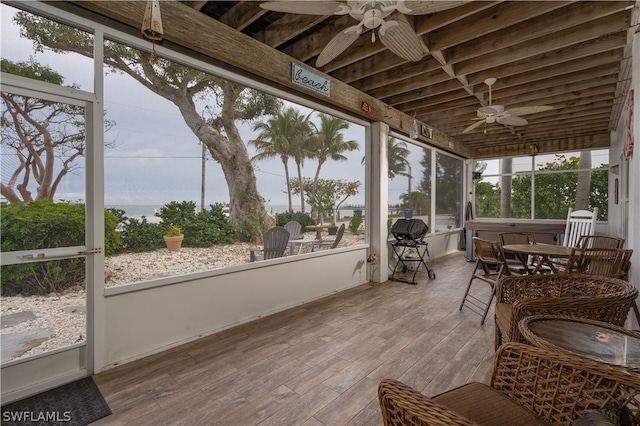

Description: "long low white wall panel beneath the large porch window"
104 245 368 369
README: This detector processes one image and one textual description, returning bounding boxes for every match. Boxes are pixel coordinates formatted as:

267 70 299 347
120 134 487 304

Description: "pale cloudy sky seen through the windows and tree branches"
1 4 421 213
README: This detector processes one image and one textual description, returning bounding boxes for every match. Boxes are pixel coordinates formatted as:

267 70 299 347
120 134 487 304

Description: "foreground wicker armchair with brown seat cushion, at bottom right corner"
378 343 640 426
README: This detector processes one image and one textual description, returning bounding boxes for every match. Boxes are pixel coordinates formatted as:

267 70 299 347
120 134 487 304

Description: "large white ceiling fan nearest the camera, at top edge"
260 0 470 67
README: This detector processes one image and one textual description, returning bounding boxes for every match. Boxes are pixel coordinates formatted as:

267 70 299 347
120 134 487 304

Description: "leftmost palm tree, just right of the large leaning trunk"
249 108 295 212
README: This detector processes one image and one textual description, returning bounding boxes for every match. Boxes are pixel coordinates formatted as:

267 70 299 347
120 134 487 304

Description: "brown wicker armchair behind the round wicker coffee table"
495 273 638 349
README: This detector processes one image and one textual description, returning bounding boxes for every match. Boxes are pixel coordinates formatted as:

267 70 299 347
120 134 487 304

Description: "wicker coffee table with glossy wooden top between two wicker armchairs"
518 315 640 371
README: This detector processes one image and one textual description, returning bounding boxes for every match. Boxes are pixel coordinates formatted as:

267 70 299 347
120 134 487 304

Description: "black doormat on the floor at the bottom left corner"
2 377 111 426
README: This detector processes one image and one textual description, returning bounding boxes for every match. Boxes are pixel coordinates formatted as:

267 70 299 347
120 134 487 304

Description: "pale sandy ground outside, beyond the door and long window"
0 231 364 362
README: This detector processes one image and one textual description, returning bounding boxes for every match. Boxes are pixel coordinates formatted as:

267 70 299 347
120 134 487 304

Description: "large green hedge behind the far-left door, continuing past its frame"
0 200 122 296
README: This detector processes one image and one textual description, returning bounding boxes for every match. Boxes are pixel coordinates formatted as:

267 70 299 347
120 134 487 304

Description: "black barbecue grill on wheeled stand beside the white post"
389 219 436 285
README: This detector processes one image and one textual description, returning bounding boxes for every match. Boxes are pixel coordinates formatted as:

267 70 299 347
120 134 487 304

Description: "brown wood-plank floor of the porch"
94 252 494 426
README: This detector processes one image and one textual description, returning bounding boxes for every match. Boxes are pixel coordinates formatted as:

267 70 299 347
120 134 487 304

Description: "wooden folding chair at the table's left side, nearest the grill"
459 237 510 325
